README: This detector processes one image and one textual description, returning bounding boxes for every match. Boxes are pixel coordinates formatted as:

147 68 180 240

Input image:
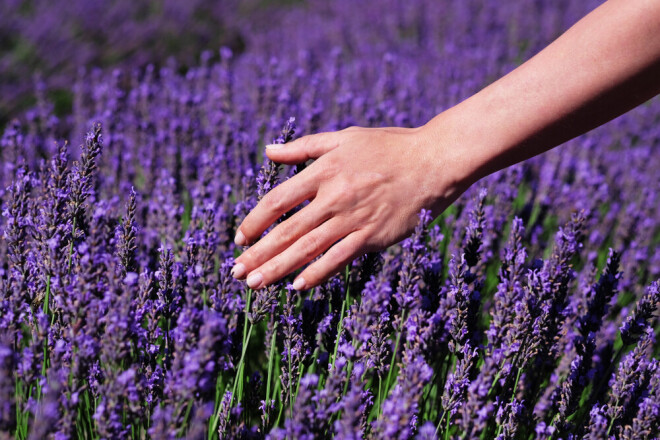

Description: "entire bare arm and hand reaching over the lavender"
232 0 660 290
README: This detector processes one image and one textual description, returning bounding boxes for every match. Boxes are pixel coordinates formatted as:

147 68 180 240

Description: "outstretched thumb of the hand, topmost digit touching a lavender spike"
266 132 341 165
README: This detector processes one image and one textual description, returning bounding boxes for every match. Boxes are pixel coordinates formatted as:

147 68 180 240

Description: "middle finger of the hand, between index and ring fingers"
232 201 331 278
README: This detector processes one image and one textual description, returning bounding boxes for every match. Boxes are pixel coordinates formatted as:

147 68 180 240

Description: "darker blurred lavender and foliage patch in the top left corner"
0 0 242 125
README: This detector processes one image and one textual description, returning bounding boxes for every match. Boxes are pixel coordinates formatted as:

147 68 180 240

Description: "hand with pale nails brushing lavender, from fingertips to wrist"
232 122 466 290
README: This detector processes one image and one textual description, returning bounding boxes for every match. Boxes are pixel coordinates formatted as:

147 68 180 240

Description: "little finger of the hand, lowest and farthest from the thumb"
293 230 367 290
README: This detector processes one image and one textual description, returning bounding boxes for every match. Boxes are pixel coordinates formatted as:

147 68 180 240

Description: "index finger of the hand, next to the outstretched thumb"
234 168 319 246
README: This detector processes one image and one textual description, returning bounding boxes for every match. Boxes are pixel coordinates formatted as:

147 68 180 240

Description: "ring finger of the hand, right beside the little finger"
241 217 347 289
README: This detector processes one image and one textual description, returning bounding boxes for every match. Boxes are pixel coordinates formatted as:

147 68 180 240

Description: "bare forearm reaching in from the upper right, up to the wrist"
424 0 660 182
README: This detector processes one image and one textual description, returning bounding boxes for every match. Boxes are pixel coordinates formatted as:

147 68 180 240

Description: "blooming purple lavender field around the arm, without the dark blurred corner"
0 0 660 440
